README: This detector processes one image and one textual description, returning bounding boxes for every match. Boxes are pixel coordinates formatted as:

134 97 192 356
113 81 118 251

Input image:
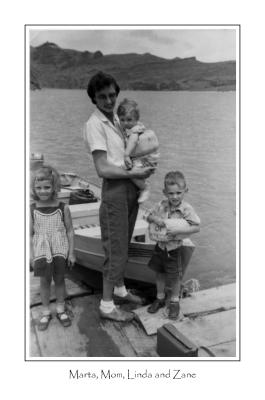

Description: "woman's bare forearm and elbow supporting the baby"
92 150 154 179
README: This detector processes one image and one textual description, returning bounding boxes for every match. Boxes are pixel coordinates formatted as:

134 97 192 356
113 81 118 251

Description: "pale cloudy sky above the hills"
29 26 236 62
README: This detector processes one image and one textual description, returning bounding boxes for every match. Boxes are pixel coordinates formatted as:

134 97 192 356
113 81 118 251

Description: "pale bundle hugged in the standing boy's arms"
149 218 189 242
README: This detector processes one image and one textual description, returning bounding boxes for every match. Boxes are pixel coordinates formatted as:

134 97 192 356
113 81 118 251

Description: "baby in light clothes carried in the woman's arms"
117 99 159 203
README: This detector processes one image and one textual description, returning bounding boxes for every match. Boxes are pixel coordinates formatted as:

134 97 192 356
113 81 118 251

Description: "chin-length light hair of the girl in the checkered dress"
31 165 61 200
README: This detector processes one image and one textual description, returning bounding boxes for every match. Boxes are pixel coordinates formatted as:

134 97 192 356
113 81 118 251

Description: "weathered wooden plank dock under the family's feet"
29 276 236 359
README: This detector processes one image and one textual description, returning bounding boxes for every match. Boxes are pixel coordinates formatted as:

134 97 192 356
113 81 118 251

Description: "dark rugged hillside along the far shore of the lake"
30 42 236 90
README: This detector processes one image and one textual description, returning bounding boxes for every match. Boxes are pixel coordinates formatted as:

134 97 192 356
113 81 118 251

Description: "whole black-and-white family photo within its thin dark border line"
25 24 240 360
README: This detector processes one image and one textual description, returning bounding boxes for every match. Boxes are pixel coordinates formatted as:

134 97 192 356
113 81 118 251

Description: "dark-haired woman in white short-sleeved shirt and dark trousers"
84 72 152 321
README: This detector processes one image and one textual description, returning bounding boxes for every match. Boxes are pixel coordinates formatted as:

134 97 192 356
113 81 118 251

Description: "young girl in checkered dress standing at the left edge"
30 166 75 331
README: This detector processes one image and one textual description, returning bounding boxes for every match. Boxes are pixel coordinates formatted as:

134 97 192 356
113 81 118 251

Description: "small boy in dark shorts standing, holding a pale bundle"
146 171 200 319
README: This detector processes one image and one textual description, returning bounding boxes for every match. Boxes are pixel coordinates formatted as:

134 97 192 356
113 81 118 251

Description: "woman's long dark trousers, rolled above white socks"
99 179 139 286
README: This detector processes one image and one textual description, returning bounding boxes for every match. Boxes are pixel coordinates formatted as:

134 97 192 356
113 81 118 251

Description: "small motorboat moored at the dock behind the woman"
59 173 194 283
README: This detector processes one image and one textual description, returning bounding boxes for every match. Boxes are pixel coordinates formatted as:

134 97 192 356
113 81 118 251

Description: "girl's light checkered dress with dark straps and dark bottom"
31 203 69 276
